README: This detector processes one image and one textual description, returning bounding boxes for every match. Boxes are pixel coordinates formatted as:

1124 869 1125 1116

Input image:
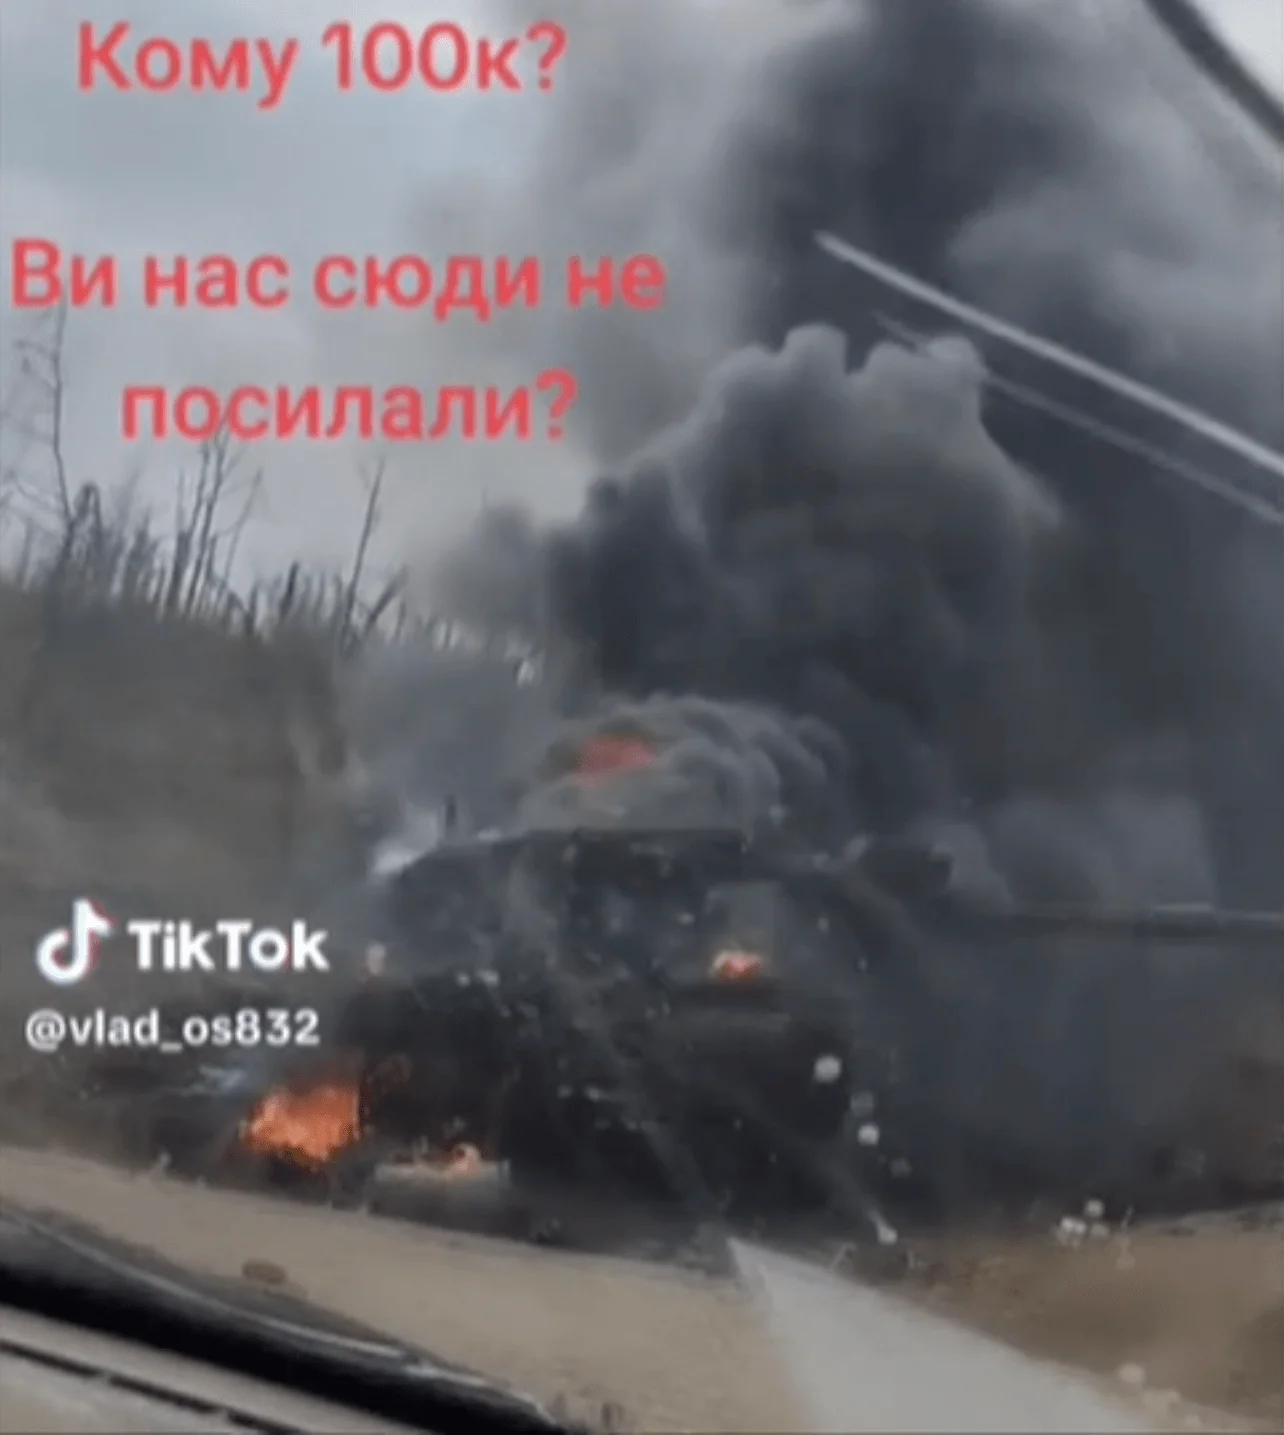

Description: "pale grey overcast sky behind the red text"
0 0 1284 582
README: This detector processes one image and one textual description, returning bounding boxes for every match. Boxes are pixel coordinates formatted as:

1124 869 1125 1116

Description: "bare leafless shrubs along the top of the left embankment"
0 309 416 657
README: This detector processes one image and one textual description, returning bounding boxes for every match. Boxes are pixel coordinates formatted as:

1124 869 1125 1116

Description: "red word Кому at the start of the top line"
79 20 300 109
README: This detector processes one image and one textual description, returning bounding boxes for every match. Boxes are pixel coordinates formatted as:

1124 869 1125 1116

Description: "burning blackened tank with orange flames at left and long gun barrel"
85 829 1284 1220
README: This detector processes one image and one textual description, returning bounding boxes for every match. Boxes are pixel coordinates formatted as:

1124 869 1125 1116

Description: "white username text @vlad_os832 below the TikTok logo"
26 1006 321 1056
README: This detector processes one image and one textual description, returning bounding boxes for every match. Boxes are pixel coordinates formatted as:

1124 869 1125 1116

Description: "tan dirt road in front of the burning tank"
0 1148 1284 1432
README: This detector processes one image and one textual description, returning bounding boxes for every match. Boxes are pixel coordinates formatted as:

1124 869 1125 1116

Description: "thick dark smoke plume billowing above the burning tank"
344 0 1284 1211
